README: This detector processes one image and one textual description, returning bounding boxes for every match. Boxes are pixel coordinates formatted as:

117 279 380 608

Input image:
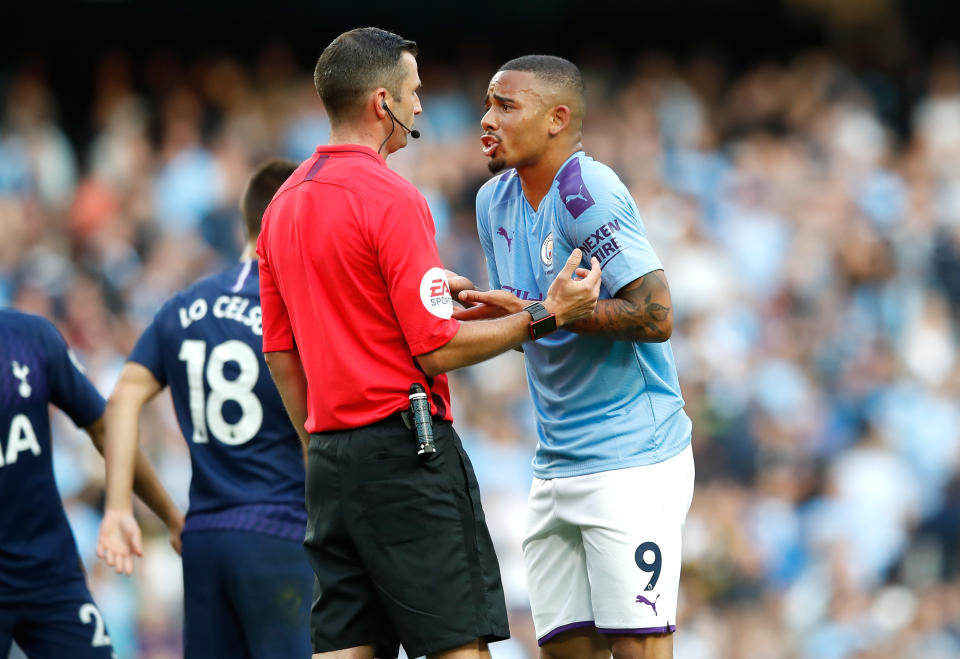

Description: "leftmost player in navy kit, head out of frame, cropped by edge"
0 309 183 659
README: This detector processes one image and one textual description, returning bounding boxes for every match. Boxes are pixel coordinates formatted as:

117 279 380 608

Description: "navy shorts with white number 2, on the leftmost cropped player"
0 581 116 659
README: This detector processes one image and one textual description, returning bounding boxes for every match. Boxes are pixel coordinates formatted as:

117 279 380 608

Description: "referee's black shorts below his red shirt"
304 415 510 658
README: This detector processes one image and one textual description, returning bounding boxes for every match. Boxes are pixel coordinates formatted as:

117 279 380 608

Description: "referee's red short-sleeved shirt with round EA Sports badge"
257 145 459 433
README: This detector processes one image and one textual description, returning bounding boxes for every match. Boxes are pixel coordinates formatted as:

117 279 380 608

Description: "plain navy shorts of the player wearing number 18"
183 530 313 659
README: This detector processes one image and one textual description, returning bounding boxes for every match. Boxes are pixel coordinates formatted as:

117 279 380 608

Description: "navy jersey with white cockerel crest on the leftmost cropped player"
0 309 105 601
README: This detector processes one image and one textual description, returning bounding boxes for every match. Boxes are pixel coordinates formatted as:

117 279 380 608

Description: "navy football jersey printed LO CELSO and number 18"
130 261 306 540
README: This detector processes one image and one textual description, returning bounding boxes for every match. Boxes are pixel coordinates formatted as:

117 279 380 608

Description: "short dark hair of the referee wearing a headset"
313 27 417 125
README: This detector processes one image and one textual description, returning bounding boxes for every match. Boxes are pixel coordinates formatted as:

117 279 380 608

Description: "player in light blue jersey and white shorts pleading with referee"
460 56 694 659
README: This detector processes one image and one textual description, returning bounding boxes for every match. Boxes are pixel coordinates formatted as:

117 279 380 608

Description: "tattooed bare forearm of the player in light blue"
564 270 673 343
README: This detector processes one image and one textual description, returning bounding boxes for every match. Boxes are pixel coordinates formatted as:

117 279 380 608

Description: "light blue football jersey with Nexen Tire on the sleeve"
477 151 691 478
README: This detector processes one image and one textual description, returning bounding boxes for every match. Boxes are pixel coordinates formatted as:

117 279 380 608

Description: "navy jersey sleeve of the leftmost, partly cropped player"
38 320 106 428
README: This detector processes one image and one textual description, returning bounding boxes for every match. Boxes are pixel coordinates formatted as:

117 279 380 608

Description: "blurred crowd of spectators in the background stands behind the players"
0 37 960 659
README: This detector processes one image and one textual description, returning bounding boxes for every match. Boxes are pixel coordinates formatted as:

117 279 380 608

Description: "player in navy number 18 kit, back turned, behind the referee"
98 160 313 659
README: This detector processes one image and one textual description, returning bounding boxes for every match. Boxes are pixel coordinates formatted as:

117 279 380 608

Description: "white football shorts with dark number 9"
523 446 694 645
